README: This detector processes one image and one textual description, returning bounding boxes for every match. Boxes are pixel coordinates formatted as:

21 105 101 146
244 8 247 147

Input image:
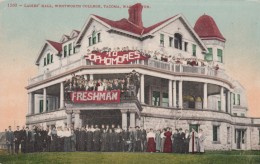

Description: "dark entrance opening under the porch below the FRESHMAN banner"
81 110 122 127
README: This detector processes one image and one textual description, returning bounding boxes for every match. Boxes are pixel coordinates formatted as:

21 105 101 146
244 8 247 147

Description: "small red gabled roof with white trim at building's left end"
35 40 62 65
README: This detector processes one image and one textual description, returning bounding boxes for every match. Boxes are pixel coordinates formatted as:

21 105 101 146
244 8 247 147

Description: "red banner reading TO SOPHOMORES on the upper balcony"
85 51 149 65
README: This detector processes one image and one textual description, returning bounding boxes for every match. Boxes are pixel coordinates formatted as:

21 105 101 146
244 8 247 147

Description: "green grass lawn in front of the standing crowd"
0 150 260 164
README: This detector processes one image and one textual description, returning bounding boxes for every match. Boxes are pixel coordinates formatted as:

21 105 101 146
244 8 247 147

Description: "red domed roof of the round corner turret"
194 14 226 42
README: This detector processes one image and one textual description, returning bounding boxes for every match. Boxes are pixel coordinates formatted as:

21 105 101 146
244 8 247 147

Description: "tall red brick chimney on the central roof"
128 3 143 28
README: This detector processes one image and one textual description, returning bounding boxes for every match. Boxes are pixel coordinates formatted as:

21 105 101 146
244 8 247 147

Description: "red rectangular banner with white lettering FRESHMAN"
70 90 120 103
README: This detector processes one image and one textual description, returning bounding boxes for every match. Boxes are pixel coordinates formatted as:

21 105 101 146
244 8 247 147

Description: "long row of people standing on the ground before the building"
6 124 206 154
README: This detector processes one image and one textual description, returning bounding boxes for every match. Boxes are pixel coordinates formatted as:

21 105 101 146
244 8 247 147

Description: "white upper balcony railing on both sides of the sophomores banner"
29 58 233 85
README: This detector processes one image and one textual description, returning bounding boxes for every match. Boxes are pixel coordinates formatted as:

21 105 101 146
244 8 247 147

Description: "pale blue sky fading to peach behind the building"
0 0 260 131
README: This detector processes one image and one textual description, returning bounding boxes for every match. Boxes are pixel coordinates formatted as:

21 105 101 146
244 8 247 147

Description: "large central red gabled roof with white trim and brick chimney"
75 3 207 52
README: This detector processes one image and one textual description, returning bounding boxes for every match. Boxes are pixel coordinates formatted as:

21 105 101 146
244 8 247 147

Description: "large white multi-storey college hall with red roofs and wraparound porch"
26 3 260 150
